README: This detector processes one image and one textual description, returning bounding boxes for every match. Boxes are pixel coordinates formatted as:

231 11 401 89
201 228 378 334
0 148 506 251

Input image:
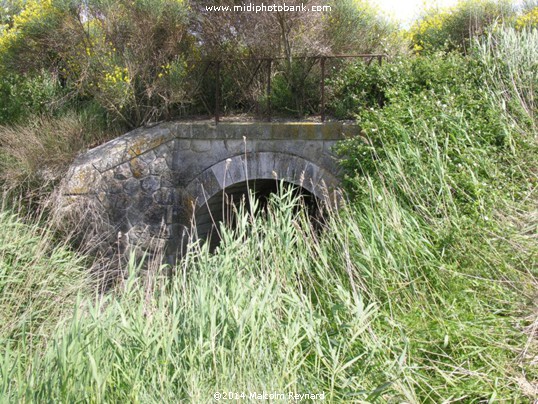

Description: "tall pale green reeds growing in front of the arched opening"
3 195 412 402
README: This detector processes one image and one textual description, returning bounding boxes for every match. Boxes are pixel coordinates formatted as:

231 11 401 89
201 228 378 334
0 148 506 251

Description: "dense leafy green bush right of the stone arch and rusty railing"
337 46 525 217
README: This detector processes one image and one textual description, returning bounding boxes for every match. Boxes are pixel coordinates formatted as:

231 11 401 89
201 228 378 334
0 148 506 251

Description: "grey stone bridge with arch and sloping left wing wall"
58 122 359 258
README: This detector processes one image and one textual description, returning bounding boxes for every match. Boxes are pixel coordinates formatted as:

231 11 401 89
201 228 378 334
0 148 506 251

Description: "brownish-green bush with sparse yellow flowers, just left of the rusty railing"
79 0 190 126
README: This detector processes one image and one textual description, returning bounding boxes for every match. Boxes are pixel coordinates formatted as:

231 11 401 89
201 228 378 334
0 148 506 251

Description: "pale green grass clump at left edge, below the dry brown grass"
0 211 90 342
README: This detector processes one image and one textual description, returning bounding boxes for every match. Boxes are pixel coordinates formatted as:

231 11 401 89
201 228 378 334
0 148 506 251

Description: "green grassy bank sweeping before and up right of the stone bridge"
0 30 538 402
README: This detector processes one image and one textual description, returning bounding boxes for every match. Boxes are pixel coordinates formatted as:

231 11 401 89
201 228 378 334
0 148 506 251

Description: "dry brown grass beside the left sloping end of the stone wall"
0 112 124 283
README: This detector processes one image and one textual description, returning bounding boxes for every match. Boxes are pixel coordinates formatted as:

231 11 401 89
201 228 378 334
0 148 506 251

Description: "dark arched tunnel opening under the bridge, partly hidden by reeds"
194 179 322 251
